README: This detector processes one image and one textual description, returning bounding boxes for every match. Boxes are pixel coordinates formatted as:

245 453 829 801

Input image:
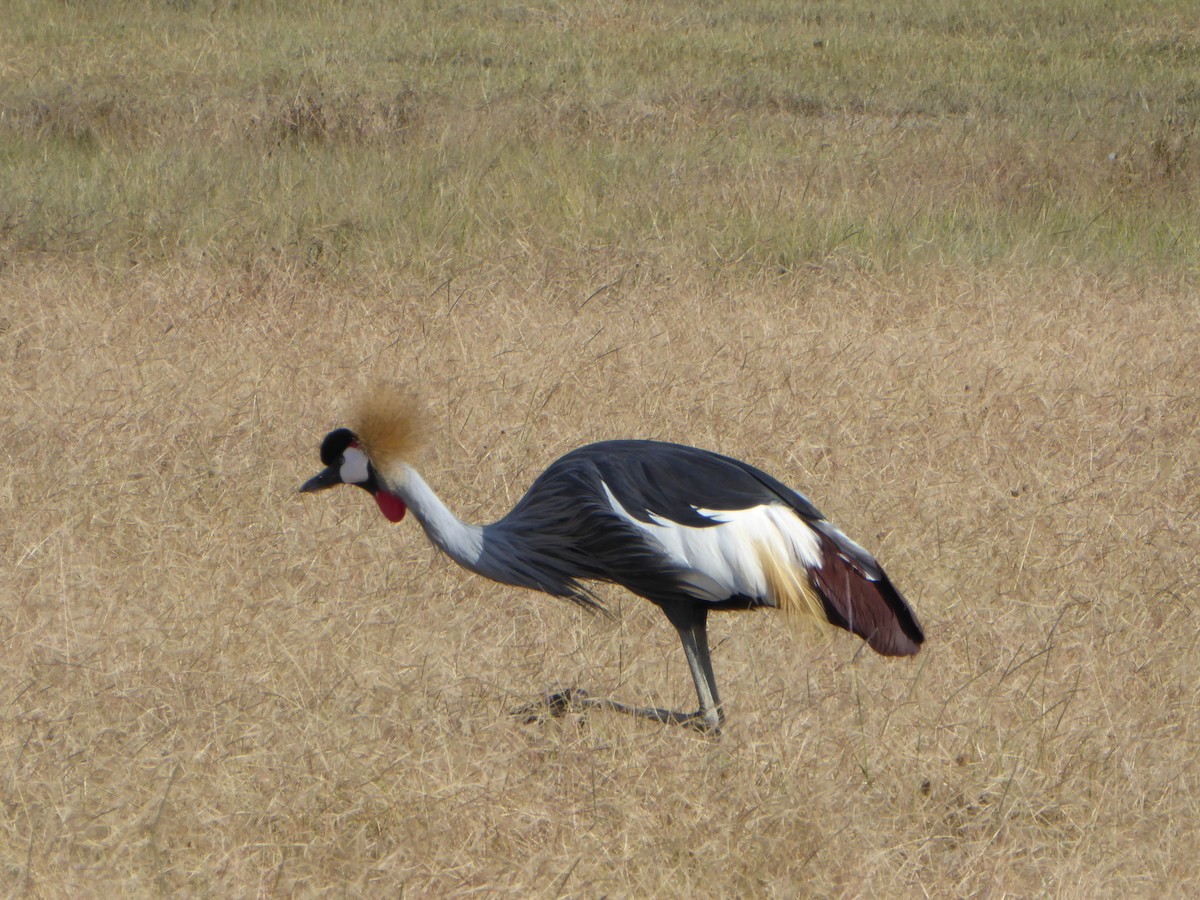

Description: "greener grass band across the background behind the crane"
0 0 1200 272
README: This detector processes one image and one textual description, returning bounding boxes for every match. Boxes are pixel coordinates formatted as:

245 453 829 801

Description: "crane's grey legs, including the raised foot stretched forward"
515 604 725 734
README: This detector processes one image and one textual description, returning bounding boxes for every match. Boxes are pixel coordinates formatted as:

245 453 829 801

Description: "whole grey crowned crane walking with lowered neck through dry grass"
300 395 925 731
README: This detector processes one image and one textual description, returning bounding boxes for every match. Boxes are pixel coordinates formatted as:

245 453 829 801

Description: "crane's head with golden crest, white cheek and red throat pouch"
300 388 419 522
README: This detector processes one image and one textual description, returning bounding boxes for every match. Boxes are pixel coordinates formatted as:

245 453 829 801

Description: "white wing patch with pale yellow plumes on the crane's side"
604 485 824 609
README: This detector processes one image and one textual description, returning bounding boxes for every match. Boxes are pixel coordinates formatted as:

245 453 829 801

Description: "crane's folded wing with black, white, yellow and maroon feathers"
587 442 924 655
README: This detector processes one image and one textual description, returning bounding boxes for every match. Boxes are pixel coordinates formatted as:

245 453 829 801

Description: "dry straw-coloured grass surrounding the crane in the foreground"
0 264 1200 896
